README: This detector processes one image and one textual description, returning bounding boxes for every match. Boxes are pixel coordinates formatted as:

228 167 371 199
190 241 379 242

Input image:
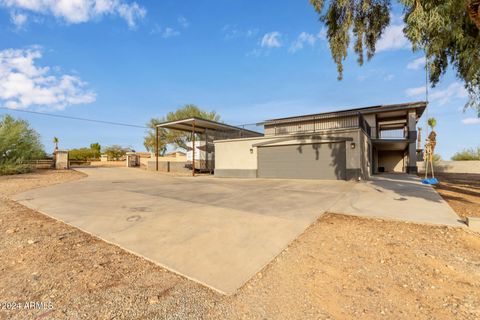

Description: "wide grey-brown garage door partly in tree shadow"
258 142 346 180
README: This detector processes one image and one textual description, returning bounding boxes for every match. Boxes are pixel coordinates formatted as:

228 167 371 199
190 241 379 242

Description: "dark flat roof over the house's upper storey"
264 101 427 125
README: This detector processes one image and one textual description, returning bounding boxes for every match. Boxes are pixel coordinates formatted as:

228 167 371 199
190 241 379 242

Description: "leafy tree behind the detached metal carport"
143 104 220 154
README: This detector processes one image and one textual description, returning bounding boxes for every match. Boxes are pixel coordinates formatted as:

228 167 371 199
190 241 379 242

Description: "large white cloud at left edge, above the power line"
0 49 96 110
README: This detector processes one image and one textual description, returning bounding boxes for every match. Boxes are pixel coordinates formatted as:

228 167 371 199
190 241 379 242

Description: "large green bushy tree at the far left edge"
0 115 45 174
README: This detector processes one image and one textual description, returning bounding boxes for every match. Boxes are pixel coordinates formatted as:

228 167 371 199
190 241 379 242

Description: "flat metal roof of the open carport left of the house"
156 117 263 136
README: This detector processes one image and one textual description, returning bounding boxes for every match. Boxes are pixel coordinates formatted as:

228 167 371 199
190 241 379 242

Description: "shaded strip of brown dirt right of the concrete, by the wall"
435 173 480 218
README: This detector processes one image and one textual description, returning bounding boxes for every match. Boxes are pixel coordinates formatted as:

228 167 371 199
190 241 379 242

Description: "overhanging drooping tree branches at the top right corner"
310 0 480 117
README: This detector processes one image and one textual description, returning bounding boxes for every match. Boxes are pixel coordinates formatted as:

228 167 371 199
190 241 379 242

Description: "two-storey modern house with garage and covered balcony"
214 102 426 180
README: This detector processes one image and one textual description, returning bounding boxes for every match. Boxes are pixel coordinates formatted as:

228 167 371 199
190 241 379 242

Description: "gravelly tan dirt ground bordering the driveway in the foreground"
0 171 480 319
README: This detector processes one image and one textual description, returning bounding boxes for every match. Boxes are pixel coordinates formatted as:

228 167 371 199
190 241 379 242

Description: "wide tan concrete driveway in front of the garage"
16 168 460 294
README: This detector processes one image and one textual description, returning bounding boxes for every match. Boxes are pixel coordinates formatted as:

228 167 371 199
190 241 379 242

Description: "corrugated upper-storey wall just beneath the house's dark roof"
265 116 359 136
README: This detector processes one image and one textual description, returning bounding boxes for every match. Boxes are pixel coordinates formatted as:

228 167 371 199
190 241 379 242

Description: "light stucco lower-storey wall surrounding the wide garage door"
215 129 371 180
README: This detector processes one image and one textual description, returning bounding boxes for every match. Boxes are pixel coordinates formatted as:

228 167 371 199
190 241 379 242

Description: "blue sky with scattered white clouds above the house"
0 0 480 159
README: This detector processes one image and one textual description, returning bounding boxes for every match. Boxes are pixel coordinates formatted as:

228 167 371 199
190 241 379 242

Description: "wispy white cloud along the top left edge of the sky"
0 0 147 28
